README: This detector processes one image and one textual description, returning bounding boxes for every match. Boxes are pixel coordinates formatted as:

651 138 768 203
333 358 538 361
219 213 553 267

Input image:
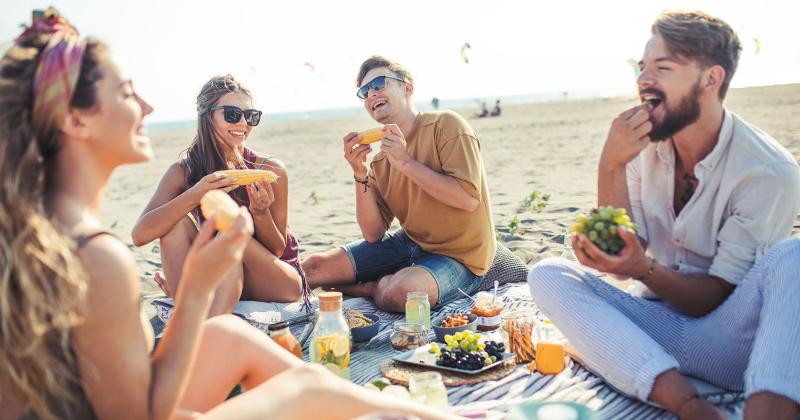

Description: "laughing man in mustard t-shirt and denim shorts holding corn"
303 56 496 312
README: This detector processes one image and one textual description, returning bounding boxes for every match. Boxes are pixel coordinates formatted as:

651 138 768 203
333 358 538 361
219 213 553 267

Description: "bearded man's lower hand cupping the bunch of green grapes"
572 227 651 278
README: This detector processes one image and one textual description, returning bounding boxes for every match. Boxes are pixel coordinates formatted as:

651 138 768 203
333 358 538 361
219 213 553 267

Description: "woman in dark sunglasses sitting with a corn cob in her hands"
132 75 304 316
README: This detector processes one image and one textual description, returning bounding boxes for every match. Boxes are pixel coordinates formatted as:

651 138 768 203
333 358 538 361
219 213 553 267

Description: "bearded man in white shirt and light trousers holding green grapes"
528 12 800 419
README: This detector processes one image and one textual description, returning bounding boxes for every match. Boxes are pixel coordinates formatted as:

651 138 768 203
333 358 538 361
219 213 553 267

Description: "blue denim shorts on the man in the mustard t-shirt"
342 229 483 305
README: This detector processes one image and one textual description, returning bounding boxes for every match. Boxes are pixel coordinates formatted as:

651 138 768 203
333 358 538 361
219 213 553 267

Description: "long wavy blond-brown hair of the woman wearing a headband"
0 12 106 419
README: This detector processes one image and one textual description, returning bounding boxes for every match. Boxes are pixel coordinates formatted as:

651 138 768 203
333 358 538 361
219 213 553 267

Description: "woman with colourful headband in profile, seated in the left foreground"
0 9 452 420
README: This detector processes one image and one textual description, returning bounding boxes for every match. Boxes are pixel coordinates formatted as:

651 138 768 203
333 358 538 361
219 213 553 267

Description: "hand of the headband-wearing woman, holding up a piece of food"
178 207 253 294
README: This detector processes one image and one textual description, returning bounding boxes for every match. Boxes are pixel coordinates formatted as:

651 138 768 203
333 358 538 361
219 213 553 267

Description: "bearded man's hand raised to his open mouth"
600 104 653 169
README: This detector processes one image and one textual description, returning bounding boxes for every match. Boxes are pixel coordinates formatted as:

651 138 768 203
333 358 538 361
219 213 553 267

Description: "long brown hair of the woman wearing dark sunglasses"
185 74 253 190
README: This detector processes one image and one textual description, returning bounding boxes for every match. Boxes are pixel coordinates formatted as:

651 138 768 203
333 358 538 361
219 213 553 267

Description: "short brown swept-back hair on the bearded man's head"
651 11 742 99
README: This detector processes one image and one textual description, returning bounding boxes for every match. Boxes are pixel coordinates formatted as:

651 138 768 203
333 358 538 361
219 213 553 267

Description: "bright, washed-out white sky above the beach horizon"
0 0 800 121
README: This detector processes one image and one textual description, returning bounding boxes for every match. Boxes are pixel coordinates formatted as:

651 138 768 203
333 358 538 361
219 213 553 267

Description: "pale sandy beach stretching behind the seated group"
98 84 800 320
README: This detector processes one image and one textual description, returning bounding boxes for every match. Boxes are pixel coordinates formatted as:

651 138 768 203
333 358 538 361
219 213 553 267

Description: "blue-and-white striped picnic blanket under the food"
154 283 744 419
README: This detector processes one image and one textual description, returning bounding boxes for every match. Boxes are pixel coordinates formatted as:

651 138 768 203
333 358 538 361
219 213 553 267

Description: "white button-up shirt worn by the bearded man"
627 110 800 284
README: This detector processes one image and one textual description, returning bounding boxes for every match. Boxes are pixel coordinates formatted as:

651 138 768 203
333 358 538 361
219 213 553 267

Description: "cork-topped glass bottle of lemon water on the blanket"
308 292 350 380
